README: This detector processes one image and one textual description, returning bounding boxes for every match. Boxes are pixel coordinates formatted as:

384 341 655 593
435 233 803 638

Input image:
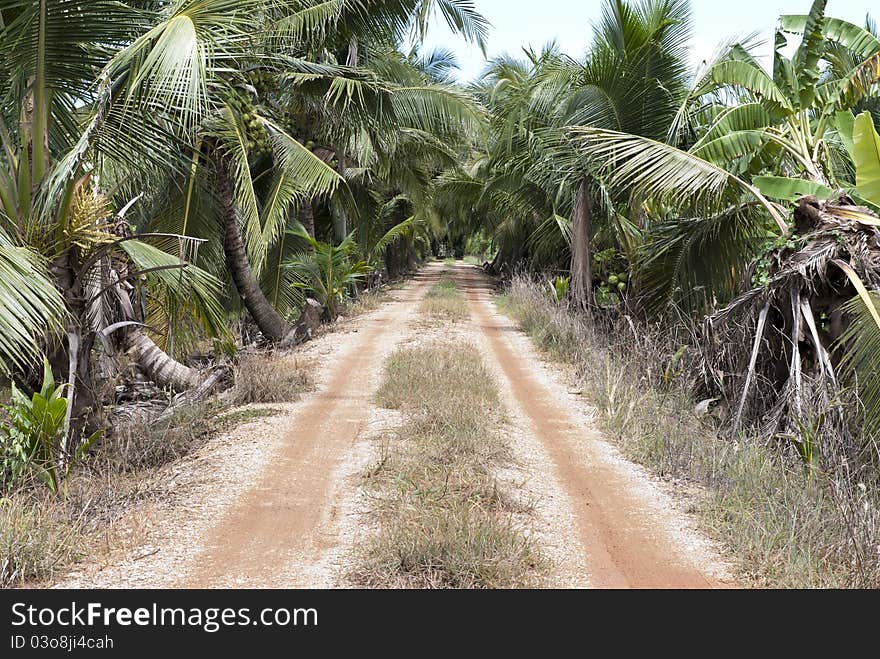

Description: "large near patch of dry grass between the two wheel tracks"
351 341 545 588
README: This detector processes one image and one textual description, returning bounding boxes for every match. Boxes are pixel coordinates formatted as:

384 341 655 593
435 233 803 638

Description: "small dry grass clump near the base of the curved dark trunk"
229 353 315 405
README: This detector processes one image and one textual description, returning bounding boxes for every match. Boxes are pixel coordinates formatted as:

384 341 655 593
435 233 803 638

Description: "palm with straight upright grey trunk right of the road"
450 0 690 306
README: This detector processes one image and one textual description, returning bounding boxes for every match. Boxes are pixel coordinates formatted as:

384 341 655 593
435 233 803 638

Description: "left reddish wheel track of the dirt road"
182 266 439 588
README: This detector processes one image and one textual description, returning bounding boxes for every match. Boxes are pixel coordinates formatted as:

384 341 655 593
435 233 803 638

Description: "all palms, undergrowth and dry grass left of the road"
0 0 487 585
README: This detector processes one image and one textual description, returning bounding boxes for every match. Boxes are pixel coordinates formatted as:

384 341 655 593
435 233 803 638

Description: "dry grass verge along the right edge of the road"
499 278 880 587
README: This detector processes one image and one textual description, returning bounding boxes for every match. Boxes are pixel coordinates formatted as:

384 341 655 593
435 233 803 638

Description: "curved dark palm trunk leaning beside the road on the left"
216 155 293 342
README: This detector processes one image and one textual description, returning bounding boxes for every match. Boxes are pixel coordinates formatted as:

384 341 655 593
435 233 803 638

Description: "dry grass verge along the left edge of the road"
0 355 313 587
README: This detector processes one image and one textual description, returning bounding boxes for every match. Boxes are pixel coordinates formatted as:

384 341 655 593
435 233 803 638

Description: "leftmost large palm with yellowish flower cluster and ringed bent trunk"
0 0 251 428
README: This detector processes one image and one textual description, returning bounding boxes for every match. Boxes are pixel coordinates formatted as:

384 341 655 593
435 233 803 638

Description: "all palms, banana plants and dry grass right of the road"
444 0 880 586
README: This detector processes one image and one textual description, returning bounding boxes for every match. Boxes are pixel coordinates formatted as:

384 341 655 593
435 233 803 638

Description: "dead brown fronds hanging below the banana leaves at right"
707 195 880 446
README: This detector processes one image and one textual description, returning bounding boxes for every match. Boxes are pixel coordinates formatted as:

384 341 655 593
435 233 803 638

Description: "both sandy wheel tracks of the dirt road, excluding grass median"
58 263 729 588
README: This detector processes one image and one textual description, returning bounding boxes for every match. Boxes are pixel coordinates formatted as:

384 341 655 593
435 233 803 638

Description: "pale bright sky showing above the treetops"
424 0 880 82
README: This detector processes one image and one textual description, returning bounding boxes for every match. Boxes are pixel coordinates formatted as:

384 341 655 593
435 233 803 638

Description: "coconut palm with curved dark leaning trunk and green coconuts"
140 0 485 341
